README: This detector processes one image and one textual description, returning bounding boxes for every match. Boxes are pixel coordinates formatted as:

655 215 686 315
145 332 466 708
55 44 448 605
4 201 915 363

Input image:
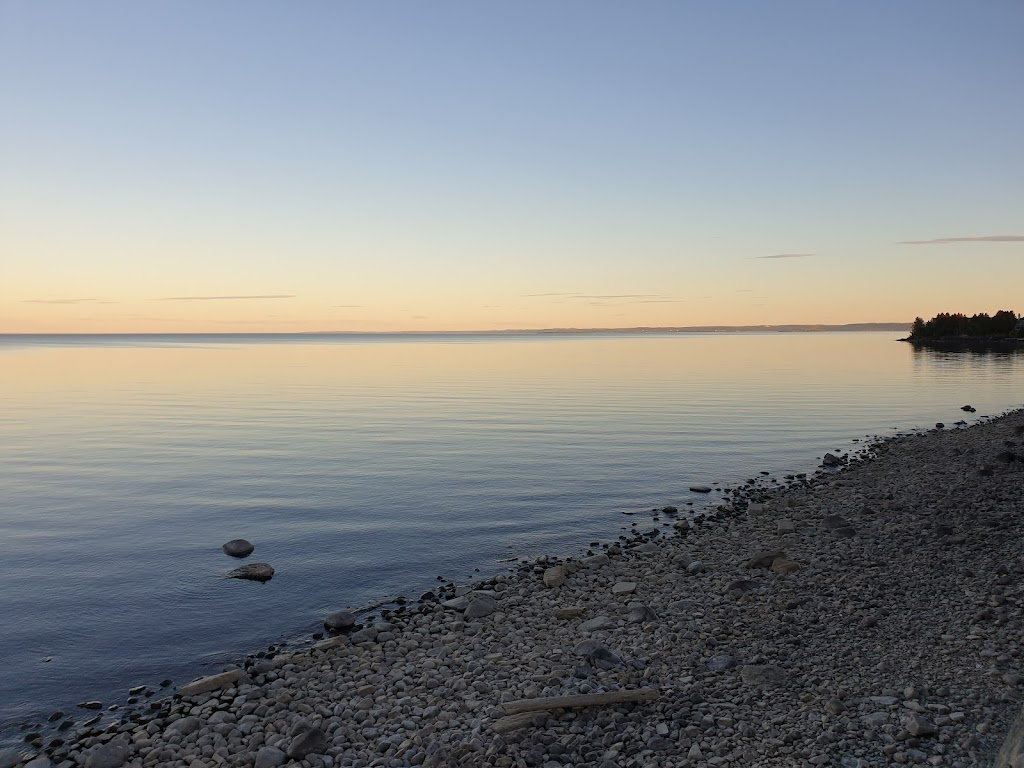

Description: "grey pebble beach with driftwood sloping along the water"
0 412 1024 768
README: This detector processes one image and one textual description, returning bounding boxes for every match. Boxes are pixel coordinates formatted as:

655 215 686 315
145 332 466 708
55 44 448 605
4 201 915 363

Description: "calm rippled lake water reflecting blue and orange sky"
0 334 1024 739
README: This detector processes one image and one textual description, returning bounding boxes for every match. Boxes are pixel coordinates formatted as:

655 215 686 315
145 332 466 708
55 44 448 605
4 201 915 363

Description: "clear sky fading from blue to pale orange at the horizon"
0 0 1024 333
